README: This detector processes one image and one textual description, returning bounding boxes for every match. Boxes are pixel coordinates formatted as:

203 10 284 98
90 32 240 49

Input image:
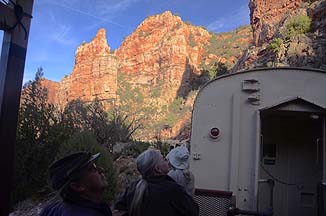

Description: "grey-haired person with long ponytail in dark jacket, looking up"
114 149 199 216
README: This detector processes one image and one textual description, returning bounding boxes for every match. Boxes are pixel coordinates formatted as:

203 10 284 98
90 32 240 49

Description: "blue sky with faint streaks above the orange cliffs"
0 0 249 82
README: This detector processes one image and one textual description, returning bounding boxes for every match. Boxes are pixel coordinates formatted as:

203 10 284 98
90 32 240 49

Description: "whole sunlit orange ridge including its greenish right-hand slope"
40 11 252 136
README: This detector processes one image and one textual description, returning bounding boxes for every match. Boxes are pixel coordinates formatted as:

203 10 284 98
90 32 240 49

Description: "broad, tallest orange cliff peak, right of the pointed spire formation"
115 11 210 104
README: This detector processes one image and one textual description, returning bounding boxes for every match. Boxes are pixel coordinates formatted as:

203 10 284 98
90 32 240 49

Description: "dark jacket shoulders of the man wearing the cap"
40 199 112 216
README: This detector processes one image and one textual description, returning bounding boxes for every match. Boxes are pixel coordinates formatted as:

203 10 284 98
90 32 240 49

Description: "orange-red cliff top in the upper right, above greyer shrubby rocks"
249 0 309 46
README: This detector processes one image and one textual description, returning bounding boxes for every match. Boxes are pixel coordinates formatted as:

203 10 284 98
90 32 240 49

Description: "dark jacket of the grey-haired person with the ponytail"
114 175 199 216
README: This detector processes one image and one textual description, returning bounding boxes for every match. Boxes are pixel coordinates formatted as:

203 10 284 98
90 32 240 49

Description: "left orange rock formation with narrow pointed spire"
46 29 118 107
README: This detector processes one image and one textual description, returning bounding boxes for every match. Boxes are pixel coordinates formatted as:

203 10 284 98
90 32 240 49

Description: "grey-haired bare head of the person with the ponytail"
137 149 169 178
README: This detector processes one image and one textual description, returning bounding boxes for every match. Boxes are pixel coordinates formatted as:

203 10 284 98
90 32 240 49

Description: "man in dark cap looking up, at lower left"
40 152 112 216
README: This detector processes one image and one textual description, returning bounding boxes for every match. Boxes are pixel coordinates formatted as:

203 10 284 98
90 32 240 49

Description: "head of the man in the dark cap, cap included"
50 152 107 201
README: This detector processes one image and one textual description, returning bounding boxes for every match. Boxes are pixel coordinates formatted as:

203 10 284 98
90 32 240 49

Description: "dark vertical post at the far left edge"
0 0 33 216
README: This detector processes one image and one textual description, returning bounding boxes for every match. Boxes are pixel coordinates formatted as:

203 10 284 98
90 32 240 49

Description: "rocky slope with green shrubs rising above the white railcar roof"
233 0 326 72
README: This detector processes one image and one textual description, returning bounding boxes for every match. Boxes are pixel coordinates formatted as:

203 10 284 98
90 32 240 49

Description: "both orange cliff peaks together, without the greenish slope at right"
43 11 214 106
